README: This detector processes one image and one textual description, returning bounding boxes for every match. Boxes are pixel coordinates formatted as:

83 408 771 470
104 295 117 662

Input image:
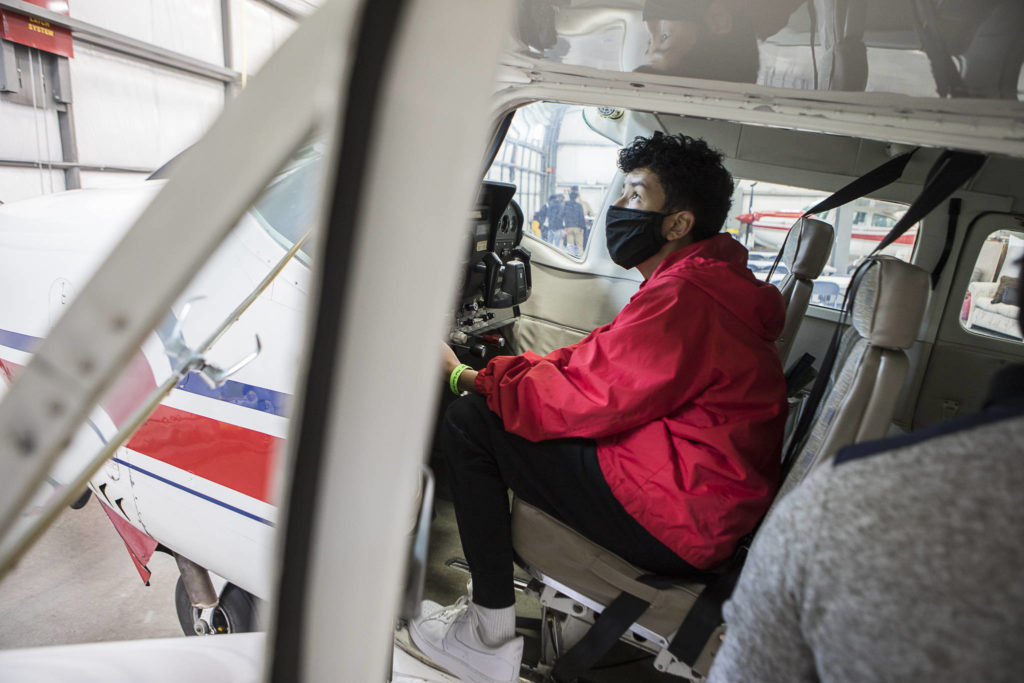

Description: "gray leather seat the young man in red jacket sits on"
512 257 929 680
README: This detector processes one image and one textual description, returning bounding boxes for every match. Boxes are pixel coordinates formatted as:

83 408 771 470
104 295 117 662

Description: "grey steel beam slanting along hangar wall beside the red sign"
0 0 237 84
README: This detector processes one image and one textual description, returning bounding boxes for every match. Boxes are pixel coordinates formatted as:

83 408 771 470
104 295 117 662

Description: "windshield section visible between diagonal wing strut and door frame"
252 142 324 263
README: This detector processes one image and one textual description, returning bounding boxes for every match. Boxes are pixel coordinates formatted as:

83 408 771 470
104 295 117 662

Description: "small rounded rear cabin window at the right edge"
961 230 1024 342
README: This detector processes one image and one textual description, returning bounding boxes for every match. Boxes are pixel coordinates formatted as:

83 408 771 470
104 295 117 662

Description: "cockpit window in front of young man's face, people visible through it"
486 102 618 260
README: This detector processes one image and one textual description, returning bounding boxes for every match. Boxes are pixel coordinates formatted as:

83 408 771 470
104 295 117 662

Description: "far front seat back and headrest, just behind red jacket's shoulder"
775 218 836 368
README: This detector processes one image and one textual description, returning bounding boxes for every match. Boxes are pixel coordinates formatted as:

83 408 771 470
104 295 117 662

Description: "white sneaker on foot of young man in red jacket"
409 596 522 683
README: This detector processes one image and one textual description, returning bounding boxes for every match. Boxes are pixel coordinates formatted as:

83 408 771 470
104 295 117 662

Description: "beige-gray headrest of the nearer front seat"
853 256 930 349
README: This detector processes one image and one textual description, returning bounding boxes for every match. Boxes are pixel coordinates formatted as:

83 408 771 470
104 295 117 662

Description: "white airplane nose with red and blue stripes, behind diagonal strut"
0 180 309 597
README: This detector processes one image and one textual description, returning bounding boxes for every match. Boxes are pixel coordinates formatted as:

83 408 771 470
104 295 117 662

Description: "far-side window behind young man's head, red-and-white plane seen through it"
725 178 918 308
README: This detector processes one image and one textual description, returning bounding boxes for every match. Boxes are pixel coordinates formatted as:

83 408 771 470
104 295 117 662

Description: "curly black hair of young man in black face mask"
618 131 733 242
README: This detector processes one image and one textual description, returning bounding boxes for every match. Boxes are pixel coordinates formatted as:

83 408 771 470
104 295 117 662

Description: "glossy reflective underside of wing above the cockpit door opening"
517 0 1024 99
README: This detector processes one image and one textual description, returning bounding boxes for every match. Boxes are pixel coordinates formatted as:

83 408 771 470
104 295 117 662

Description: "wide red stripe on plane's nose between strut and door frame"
128 405 282 503
